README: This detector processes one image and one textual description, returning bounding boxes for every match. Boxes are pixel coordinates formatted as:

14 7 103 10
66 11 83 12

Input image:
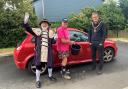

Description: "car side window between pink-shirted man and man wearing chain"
70 31 88 42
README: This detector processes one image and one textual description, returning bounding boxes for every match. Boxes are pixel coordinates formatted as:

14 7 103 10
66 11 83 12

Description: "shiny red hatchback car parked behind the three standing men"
14 28 117 73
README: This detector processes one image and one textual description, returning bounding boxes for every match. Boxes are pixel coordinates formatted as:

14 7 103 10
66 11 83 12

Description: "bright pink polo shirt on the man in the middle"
57 26 70 52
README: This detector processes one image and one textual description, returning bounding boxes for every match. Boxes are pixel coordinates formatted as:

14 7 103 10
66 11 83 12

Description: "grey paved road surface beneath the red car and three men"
0 42 128 89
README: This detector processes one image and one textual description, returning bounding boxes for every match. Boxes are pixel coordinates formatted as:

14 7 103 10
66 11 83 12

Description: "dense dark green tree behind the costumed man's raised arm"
0 0 37 48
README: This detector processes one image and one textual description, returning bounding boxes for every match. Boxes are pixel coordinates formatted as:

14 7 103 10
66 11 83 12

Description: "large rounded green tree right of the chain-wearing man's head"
97 1 125 30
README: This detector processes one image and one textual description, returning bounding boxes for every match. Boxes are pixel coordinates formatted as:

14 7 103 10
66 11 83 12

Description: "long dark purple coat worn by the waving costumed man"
23 23 54 68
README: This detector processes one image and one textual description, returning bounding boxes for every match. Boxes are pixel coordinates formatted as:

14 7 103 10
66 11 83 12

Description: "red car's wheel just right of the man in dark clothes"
104 47 115 63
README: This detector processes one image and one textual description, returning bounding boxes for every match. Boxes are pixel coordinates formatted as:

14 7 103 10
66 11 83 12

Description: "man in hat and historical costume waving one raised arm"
24 13 56 88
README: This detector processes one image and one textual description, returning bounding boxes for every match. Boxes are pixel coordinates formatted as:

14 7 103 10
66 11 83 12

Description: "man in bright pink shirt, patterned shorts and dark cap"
57 18 73 79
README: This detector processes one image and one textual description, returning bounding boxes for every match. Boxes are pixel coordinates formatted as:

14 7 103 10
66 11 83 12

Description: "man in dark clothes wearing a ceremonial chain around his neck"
89 12 106 74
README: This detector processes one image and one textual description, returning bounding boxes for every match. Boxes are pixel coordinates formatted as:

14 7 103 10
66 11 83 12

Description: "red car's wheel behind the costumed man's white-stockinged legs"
28 60 47 74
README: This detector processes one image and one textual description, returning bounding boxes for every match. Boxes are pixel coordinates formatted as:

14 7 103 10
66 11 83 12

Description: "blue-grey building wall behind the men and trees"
33 0 104 22
